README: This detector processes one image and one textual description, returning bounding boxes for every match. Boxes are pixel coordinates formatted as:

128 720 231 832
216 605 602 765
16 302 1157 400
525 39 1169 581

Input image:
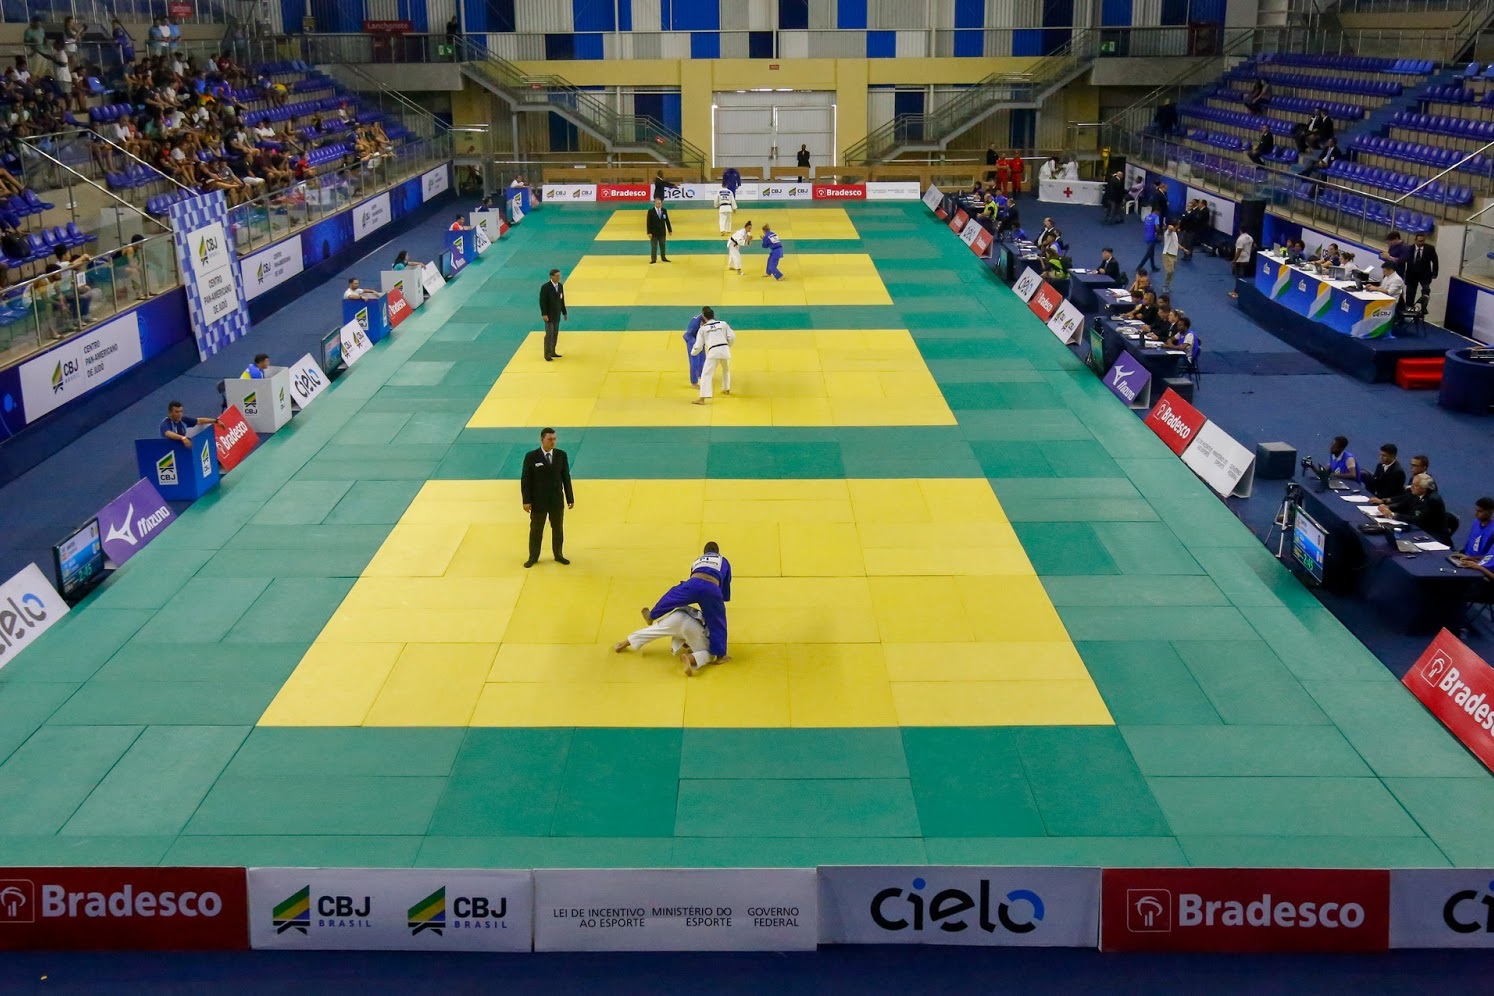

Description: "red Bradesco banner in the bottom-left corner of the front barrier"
0 868 249 951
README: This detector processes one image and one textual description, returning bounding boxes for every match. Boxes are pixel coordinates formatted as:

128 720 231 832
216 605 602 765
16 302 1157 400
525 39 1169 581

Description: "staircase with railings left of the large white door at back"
457 39 705 172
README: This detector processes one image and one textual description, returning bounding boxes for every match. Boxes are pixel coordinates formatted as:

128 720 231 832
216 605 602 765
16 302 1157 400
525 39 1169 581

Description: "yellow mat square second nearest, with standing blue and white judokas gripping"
468 331 955 429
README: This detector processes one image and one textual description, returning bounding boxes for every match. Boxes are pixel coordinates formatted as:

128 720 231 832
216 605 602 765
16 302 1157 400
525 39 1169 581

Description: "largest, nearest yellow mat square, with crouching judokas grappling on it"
260 479 1112 727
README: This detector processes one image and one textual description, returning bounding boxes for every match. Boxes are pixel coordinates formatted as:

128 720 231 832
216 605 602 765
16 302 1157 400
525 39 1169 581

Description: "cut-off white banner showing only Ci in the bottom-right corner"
1391 868 1494 948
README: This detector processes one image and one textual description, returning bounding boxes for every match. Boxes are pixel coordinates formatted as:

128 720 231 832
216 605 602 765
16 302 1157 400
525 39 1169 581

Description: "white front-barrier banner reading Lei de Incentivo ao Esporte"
535 868 819 951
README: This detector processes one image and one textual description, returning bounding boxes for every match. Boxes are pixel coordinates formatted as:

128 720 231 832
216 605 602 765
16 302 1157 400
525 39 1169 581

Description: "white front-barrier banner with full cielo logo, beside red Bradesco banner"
819 866 1100 948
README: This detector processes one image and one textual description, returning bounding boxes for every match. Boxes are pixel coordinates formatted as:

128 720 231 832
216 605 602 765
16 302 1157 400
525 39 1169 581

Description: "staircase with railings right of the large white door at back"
843 30 1100 166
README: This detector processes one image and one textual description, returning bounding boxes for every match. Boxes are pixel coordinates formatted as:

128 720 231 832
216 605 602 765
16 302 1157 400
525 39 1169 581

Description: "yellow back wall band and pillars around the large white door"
507 58 1033 160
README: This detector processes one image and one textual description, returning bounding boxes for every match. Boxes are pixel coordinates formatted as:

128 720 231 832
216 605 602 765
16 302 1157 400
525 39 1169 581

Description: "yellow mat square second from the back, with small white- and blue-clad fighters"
562 255 892 306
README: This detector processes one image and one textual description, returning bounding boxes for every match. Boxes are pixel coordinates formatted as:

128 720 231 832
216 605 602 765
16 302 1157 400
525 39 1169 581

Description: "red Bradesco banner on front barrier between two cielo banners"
1100 868 1391 951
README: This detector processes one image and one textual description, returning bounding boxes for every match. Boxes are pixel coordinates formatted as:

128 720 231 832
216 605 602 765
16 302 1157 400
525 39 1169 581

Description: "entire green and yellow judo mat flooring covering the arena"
0 202 1494 868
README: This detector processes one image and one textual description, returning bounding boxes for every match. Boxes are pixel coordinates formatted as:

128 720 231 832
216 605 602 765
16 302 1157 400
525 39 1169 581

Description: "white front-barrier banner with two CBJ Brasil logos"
248 868 533 951
